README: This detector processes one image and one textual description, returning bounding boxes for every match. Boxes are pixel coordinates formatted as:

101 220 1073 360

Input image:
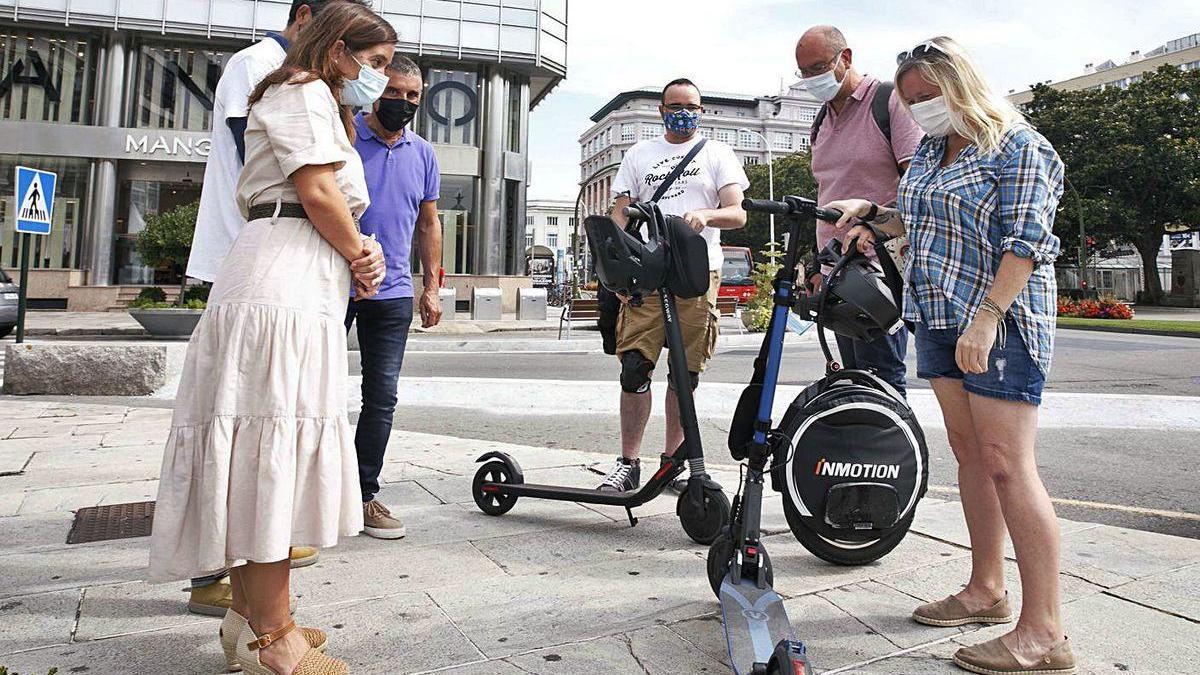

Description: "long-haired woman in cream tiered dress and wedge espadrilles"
150 2 397 675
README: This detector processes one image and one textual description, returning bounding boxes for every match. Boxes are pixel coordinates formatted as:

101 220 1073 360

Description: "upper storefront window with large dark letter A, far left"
0 26 96 124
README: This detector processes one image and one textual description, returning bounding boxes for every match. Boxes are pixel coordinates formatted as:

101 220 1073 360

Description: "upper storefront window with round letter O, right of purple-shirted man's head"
420 67 482 148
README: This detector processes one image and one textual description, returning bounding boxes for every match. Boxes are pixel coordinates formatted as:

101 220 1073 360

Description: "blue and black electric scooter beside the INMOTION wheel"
708 197 841 675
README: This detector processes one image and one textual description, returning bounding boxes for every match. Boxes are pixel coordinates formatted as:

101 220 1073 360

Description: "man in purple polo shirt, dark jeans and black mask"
346 55 442 539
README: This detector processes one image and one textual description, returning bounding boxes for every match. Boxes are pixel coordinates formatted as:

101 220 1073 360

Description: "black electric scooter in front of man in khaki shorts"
472 202 731 545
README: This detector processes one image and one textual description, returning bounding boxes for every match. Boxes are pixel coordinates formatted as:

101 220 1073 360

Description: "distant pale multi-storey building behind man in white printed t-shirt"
580 83 821 214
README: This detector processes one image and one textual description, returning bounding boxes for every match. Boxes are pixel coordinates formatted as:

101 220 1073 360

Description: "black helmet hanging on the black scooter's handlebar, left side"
583 216 667 297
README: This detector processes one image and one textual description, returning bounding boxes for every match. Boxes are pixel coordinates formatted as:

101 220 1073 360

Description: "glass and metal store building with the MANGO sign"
0 0 566 304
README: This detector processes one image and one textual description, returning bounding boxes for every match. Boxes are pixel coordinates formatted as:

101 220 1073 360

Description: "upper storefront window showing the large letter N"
130 42 236 131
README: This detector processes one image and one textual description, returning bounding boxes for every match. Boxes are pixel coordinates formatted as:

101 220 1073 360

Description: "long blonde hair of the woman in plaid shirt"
895 35 1025 153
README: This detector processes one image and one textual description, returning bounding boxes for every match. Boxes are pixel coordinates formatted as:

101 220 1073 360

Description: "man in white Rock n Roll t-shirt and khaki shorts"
600 79 750 491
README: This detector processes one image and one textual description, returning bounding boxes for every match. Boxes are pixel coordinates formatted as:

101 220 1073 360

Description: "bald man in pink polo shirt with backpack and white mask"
796 25 924 394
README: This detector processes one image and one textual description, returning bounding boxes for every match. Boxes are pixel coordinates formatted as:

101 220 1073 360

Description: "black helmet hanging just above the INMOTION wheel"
797 240 904 340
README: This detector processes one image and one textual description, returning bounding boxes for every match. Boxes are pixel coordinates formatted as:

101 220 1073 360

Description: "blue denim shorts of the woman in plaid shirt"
916 317 1046 405
